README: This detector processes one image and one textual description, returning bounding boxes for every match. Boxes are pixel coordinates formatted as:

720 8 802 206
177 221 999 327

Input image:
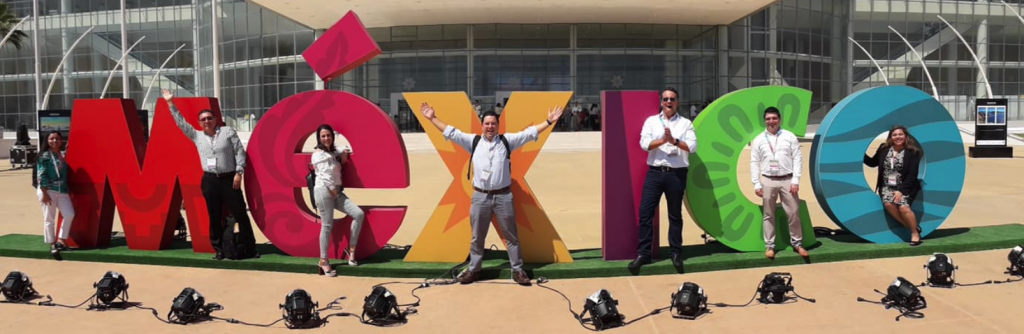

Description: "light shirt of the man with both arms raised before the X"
442 125 539 191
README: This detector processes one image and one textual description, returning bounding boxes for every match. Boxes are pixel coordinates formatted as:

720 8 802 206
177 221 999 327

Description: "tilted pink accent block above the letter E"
302 11 381 81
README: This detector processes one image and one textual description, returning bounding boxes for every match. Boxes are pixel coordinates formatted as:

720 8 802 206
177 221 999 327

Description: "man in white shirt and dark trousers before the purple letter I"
629 87 697 272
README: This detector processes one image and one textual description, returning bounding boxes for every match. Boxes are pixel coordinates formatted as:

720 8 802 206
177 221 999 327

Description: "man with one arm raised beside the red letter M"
163 89 259 260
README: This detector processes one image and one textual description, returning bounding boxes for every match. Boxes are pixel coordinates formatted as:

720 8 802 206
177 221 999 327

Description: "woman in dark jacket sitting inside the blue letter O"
864 125 925 246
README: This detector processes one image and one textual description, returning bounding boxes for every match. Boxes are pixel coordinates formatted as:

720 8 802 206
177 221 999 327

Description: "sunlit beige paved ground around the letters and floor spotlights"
0 135 1024 333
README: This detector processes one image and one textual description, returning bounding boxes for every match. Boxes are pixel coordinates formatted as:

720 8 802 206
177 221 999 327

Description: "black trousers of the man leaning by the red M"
201 173 256 254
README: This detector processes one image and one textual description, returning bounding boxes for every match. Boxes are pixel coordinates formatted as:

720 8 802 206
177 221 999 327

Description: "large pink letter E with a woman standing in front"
245 90 410 258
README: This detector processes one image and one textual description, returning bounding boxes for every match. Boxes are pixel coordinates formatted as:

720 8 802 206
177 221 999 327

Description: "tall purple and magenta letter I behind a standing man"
601 91 660 260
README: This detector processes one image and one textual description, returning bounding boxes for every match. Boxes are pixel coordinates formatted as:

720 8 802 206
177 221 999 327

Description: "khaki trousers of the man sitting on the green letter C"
761 175 804 249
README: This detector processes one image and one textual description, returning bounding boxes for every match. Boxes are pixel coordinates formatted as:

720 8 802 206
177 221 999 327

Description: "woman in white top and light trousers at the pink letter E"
310 124 365 277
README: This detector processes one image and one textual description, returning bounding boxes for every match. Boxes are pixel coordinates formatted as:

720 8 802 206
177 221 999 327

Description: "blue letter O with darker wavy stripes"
810 86 967 244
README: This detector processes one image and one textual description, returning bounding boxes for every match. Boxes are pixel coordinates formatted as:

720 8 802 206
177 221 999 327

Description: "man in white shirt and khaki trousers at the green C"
751 107 807 258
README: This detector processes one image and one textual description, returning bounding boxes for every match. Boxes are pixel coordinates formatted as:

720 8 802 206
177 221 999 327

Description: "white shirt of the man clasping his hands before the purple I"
640 112 697 168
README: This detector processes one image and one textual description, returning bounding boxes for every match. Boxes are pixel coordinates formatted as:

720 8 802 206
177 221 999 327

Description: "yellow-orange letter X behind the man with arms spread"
402 92 572 263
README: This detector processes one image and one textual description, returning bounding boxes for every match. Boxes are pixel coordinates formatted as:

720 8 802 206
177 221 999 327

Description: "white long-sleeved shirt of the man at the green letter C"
751 129 804 190
